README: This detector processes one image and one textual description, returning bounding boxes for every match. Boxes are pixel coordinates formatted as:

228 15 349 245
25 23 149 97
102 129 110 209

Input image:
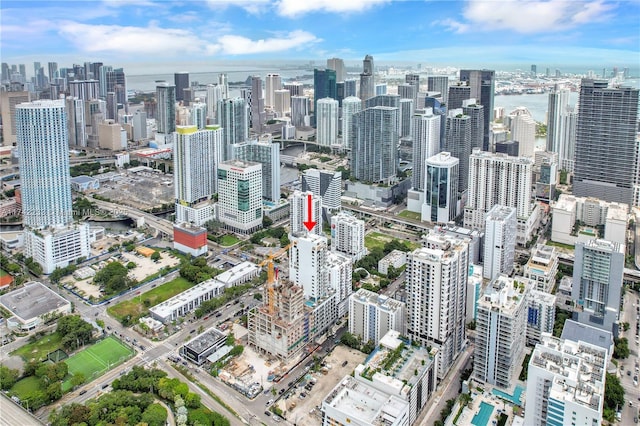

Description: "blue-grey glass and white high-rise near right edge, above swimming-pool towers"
571 239 625 334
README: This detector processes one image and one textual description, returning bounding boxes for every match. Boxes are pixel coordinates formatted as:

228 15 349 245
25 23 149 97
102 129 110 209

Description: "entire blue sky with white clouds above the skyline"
0 0 640 75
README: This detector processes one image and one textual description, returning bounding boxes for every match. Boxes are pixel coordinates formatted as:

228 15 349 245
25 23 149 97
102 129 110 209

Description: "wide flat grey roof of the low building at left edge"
0 281 69 322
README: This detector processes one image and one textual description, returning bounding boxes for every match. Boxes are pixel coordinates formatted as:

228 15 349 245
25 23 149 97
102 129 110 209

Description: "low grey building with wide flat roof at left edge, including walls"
0 281 71 331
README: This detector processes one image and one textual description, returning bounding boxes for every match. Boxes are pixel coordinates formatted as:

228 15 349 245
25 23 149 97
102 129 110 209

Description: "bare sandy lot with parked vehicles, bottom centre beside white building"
278 345 366 426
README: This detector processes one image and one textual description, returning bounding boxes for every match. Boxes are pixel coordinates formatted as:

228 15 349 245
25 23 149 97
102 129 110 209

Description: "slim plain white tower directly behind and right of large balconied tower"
482 204 517 280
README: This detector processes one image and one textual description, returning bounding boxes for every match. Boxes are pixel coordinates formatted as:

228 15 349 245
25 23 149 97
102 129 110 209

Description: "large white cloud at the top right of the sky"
435 0 615 34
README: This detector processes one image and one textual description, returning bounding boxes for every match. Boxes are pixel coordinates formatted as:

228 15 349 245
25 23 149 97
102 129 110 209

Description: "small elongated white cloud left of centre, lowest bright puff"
218 30 320 55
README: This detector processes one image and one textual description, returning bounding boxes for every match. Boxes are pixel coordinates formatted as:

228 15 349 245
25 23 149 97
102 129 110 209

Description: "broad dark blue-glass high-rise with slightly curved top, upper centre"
351 106 398 183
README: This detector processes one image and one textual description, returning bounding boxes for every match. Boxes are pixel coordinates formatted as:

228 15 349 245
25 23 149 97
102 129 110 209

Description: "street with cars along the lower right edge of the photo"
619 290 640 425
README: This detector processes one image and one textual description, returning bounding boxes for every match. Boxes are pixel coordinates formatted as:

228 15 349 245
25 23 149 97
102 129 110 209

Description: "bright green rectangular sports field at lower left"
62 337 133 390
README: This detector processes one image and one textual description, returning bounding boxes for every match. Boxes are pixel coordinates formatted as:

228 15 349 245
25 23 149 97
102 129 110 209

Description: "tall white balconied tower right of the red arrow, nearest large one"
406 232 469 379
